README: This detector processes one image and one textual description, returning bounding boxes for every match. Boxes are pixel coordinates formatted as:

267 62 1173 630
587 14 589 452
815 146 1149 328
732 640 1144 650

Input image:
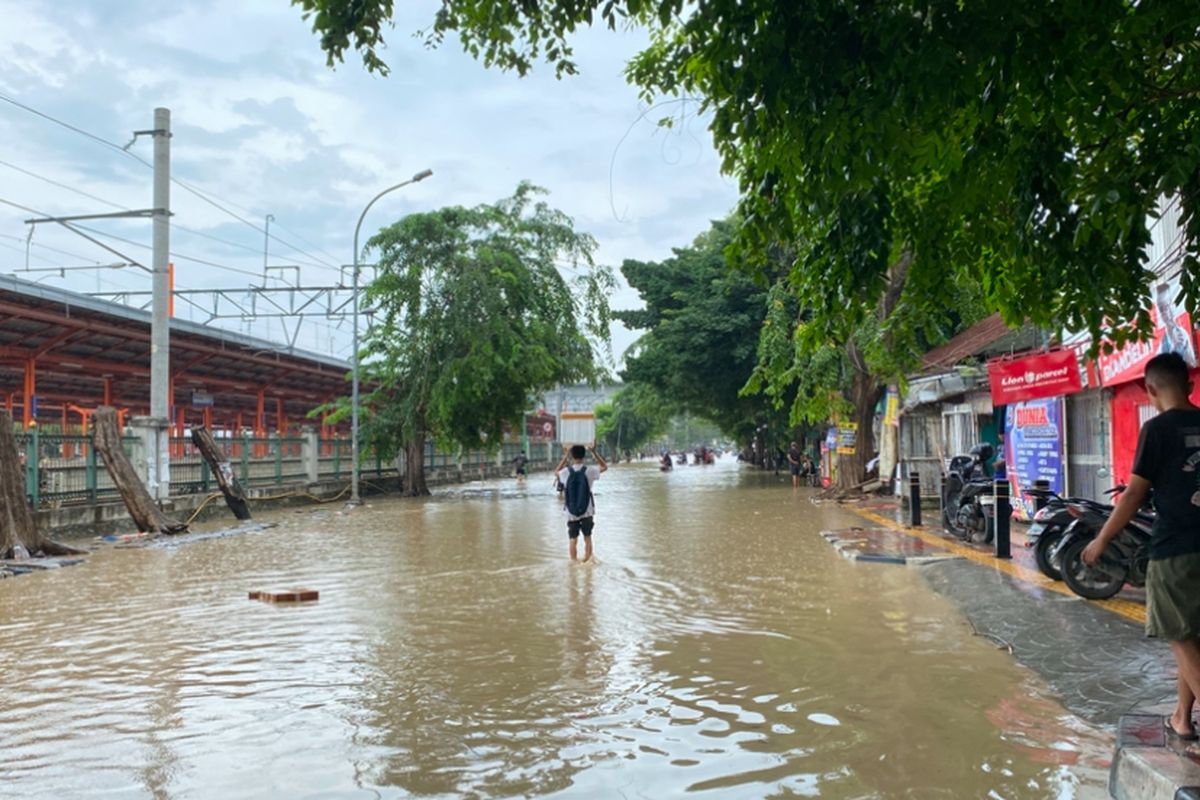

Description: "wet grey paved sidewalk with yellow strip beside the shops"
823 498 1200 800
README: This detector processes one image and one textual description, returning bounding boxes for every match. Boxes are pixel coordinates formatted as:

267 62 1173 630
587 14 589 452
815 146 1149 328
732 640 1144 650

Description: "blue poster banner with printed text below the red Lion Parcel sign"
1004 397 1066 519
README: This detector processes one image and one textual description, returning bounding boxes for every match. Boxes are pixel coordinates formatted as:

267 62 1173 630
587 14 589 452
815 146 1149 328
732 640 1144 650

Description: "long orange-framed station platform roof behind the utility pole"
0 276 350 429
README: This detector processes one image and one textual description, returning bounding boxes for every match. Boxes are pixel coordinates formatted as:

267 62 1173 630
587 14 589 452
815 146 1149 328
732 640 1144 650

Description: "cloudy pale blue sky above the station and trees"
0 0 736 367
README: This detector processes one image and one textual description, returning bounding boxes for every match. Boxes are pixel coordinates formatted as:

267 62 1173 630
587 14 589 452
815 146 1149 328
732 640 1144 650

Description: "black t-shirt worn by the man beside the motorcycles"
1133 409 1200 559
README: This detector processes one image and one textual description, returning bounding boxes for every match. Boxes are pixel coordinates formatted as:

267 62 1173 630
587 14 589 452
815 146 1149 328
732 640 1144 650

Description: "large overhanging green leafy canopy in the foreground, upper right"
295 0 1200 347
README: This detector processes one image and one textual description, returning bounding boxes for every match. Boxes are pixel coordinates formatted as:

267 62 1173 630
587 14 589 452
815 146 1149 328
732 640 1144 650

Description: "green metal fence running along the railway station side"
17 429 557 507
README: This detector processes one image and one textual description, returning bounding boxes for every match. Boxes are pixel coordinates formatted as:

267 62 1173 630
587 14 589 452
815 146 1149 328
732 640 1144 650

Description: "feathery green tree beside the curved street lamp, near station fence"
348 184 614 494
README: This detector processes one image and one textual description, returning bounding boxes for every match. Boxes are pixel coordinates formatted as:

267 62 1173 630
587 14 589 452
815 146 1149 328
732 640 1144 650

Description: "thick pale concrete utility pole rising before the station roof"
146 108 173 500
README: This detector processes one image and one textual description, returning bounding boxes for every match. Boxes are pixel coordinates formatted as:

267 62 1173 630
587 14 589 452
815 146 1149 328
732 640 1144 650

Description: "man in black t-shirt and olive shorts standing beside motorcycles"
1084 353 1200 741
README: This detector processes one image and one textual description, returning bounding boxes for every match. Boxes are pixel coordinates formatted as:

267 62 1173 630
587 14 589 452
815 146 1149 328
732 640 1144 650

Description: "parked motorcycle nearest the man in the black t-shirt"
1055 494 1154 600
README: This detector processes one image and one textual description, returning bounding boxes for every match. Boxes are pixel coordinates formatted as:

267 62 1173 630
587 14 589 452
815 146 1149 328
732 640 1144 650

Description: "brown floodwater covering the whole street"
0 459 1108 800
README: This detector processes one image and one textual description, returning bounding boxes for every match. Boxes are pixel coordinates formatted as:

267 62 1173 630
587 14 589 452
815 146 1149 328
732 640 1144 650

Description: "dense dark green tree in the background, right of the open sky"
613 221 769 440
